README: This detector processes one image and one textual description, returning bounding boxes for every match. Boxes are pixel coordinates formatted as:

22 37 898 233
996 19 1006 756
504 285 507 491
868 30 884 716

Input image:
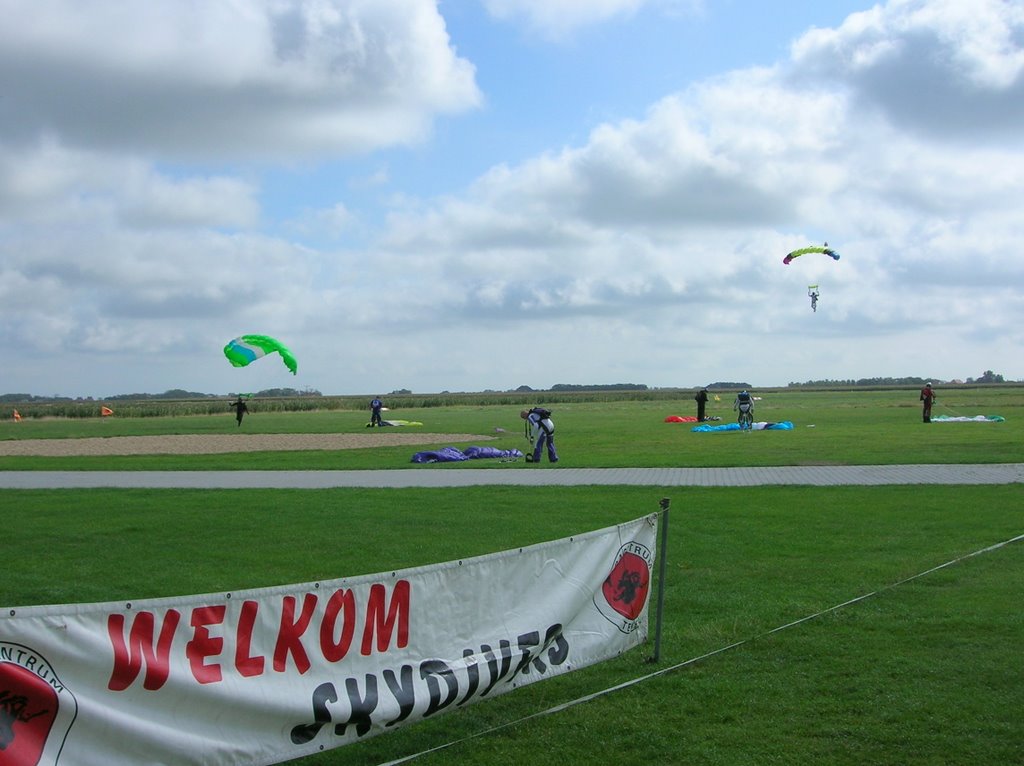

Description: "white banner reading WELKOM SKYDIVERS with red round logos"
0 515 657 766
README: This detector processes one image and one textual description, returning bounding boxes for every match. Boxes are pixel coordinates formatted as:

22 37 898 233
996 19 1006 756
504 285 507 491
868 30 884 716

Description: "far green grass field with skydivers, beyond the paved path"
0 387 1024 471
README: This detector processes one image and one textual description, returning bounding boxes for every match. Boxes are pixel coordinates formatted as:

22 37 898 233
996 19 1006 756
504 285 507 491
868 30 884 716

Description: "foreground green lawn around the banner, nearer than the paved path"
0 485 1024 766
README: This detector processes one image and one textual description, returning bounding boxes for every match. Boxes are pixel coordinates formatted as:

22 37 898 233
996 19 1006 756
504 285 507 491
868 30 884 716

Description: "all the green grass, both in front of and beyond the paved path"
0 388 1024 766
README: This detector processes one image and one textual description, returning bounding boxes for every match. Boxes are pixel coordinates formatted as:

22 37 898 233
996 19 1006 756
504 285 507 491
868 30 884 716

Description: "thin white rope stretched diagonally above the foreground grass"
379 535 1024 766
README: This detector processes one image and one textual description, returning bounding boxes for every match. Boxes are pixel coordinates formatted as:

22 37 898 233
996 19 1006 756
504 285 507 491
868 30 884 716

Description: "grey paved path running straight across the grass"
0 463 1024 490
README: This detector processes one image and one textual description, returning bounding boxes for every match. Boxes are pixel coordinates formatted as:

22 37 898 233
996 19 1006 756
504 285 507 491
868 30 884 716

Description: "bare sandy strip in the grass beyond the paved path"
0 430 495 458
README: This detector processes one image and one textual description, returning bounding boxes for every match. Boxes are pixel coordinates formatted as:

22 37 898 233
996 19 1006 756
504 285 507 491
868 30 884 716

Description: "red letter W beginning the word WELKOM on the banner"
106 609 181 691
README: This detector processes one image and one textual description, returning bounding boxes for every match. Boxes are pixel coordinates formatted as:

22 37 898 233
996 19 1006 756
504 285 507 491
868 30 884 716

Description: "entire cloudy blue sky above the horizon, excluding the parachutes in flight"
0 0 1024 397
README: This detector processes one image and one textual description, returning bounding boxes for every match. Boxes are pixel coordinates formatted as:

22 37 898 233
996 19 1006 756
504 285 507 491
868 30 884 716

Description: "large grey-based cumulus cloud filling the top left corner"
0 0 480 161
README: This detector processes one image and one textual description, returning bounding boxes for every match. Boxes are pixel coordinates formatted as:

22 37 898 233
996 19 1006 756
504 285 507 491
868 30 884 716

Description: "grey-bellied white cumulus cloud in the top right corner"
792 0 1024 141
